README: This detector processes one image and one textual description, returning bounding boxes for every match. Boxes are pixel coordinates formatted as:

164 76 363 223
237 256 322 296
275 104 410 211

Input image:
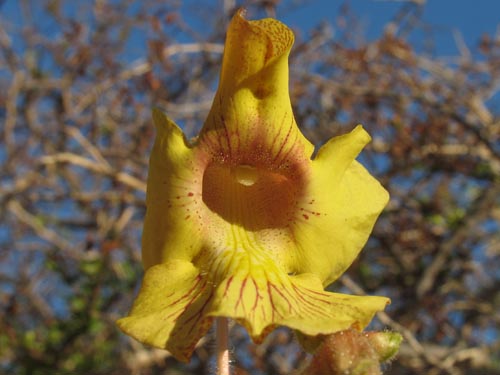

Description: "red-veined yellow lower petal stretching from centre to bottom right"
205 252 389 342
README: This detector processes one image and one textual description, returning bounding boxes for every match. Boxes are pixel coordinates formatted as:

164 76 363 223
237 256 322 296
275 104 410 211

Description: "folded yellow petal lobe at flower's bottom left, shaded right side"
117 260 213 362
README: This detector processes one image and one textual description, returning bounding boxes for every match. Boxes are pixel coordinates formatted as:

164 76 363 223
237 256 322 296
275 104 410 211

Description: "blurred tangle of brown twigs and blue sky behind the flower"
0 0 500 375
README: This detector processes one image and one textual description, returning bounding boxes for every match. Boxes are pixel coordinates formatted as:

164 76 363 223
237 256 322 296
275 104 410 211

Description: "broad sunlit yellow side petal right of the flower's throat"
294 126 389 285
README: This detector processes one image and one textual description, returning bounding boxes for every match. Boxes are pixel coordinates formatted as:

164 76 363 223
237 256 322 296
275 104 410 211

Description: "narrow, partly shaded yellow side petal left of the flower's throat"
142 110 208 269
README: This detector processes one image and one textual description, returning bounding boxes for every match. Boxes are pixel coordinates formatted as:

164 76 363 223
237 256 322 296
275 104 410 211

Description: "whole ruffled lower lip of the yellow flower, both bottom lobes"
118 251 389 361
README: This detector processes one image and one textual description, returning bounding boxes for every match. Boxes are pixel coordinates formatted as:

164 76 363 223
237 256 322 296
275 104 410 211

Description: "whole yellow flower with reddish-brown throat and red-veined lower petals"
118 12 388 361
